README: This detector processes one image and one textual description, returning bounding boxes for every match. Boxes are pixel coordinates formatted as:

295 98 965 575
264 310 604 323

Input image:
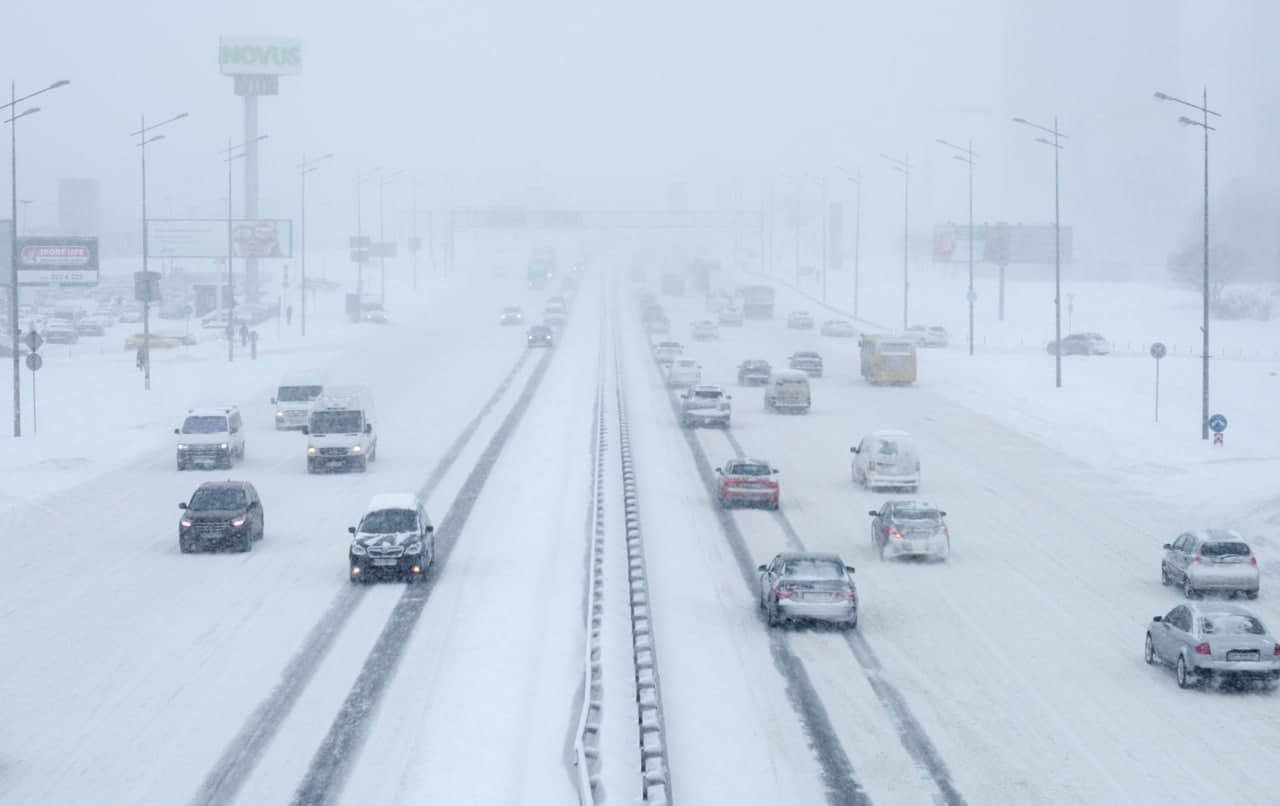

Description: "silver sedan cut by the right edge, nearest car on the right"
1143 601 1280 688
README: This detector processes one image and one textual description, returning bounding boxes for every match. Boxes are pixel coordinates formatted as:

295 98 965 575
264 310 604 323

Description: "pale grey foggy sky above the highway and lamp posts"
0 0 1280 265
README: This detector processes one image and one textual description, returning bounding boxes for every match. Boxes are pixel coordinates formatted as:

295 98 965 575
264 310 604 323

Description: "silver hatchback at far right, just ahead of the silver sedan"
1160 530 1262 599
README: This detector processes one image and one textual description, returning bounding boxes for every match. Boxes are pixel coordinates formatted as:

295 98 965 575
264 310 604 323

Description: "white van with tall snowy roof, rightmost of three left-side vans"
302 386 378 473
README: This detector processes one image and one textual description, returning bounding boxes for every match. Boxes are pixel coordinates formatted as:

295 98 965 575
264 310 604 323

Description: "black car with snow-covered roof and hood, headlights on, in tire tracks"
347 493 435 582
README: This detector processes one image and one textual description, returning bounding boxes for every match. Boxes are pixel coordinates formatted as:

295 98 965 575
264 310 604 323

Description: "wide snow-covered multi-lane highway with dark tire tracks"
0 267 1280 806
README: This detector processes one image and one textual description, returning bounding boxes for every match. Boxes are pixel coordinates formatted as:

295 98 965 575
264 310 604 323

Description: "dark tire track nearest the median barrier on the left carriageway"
291 351 554 806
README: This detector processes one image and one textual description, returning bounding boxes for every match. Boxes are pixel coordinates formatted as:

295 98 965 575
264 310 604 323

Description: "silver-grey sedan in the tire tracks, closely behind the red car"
756 551 858 629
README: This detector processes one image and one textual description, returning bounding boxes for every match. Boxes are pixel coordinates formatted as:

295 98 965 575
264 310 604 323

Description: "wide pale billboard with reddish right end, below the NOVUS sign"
147 219 293 258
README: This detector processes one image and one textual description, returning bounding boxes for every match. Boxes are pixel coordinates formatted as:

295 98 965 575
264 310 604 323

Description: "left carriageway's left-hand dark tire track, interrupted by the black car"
191 351 532 806
